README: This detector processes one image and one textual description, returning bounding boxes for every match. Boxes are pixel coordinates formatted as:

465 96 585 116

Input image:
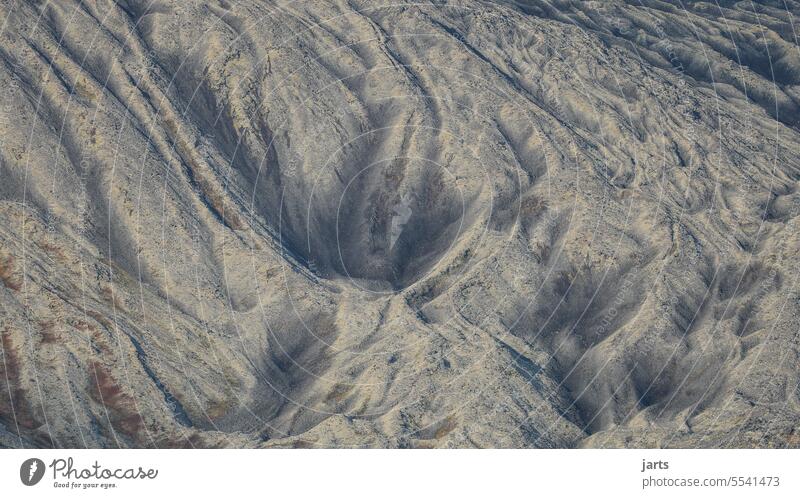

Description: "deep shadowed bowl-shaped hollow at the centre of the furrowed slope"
302 158 471 291
